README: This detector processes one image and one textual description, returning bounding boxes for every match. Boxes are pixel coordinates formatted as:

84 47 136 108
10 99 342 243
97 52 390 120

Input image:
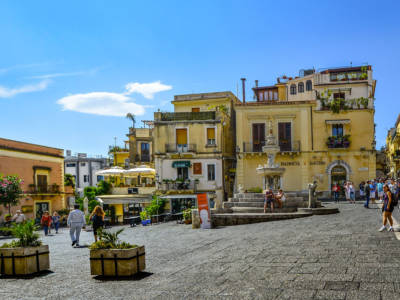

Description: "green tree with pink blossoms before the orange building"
0 174 23 214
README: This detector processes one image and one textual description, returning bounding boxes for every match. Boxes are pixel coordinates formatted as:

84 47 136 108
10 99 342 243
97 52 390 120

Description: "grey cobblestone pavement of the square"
0 203 400 300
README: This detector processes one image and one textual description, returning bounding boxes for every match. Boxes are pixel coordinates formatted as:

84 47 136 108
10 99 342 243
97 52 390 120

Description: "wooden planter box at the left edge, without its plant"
0 245 50 275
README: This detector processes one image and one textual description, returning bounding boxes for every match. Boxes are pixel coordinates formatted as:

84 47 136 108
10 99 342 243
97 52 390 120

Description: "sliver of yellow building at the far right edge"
386 115 400 178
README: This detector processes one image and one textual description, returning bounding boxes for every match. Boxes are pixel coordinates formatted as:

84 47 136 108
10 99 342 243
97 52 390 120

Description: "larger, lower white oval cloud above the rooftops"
57 92 145 117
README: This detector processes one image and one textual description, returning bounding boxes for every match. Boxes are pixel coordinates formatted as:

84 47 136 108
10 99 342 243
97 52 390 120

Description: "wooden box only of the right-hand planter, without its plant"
90 246 146 277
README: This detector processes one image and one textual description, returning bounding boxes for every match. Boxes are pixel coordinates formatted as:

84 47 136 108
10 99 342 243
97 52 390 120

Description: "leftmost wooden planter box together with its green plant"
0 220 50 276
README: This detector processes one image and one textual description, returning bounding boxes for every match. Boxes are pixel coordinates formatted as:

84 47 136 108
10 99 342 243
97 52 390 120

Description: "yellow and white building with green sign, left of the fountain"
153 92 240 211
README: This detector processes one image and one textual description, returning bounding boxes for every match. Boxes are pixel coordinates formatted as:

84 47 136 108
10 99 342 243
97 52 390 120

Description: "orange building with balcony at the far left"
0 138 74 219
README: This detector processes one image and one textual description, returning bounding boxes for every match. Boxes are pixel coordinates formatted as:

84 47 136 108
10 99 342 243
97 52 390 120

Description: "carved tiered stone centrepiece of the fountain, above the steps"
257 120 285 190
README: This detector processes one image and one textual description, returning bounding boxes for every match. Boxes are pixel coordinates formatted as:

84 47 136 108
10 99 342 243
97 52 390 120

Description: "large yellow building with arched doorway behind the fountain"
235 66 376 196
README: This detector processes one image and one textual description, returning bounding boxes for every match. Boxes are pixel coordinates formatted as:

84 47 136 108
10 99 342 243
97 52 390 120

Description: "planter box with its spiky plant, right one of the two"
89 229 146 277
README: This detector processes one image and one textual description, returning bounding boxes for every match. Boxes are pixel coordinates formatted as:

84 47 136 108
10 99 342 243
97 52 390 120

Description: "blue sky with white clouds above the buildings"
0 0 400 155
